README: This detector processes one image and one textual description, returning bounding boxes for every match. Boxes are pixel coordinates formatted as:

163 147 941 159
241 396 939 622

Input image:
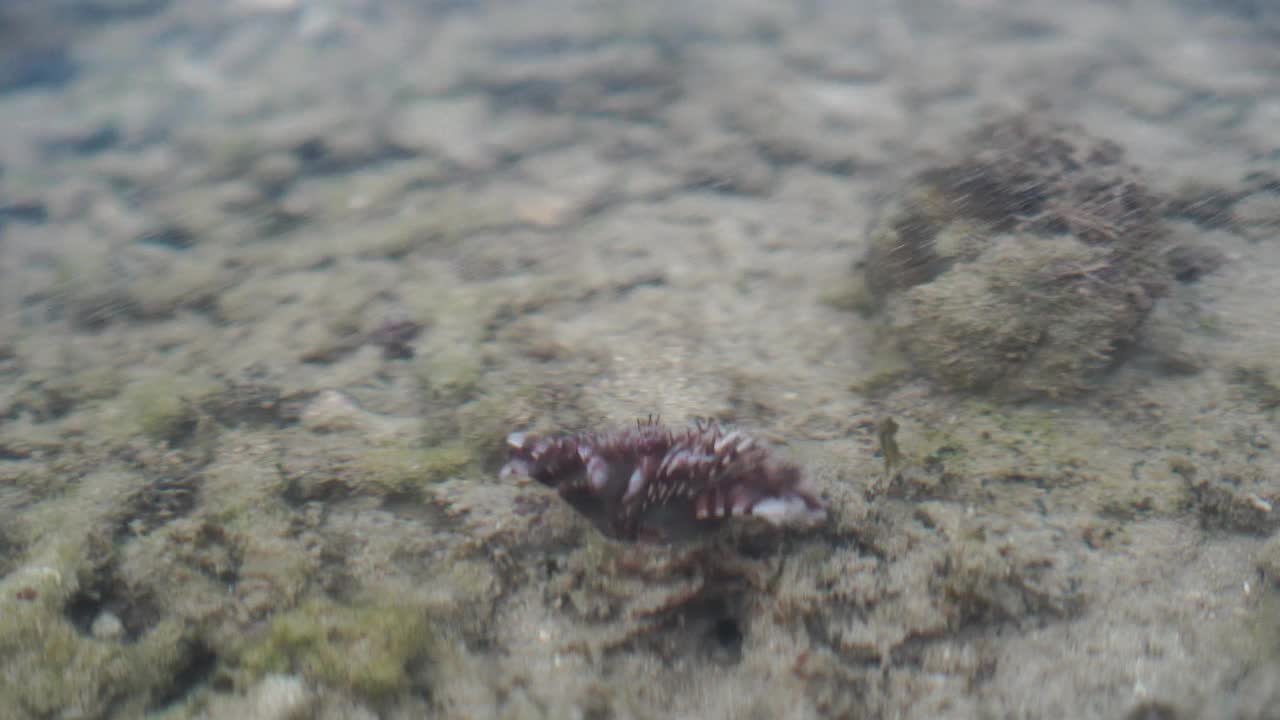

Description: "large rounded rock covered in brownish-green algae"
860 114 1169 397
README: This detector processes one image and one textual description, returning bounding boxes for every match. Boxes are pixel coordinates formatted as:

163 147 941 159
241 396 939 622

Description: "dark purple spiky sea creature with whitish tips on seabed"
502 416 826 542
